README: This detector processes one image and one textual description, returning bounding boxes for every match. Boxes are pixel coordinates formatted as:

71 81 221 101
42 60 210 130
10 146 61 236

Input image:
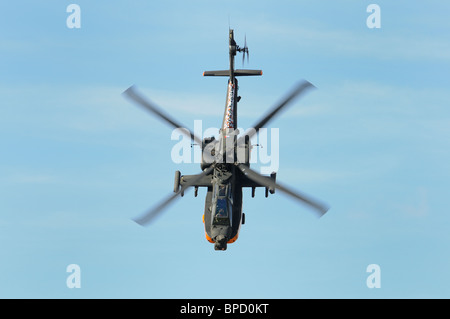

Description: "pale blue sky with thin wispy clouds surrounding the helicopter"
0 1 450 298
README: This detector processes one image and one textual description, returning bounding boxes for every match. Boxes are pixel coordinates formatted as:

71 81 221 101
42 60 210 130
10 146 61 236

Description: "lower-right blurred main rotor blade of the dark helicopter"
238 164 329 217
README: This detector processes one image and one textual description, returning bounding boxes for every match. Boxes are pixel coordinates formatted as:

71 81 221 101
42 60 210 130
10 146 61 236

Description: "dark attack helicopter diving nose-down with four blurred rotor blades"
123 29 329 251
